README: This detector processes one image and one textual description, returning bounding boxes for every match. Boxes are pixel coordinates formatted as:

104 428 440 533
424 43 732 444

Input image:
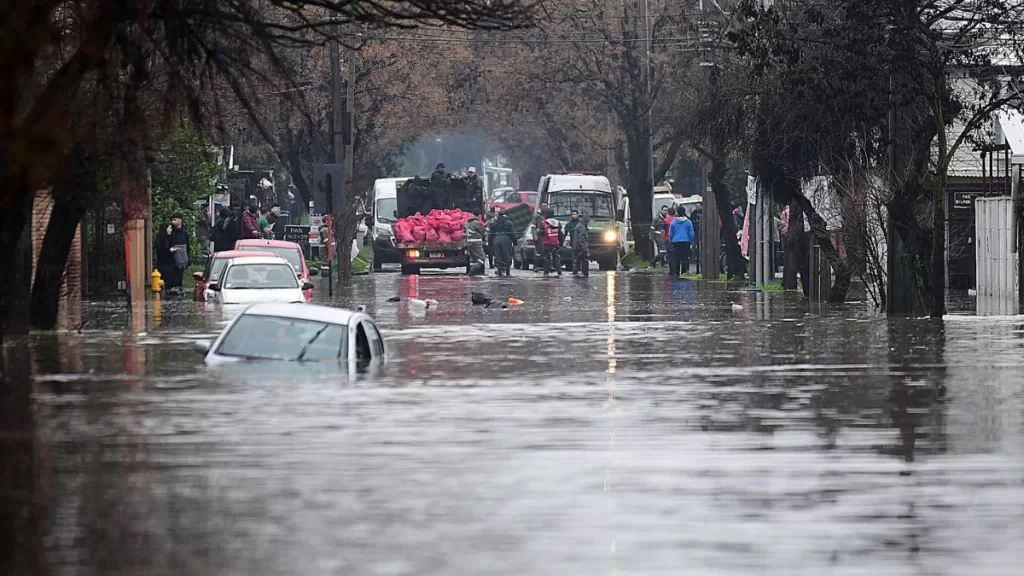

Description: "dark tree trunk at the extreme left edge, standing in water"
0 188 33 340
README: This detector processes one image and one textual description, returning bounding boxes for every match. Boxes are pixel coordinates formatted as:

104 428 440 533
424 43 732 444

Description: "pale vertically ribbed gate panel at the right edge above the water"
974 196 1019 316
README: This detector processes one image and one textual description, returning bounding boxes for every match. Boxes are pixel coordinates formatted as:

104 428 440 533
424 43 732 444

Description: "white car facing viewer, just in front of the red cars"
209 256 313 304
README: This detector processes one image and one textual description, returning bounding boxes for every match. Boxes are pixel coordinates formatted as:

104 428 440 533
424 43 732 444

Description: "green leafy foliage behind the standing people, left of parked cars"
153 126 218 262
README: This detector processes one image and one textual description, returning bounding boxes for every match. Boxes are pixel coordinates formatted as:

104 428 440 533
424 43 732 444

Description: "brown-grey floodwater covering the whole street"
0 273 1024 576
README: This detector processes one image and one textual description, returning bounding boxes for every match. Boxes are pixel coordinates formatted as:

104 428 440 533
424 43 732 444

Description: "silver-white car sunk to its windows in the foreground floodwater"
199 304 386 370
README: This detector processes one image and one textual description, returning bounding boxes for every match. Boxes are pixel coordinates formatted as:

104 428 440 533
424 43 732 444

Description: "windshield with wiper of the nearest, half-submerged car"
216 314 348 362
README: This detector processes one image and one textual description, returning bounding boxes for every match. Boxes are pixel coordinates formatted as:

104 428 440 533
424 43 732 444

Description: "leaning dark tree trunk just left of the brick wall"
30 198 85 330
